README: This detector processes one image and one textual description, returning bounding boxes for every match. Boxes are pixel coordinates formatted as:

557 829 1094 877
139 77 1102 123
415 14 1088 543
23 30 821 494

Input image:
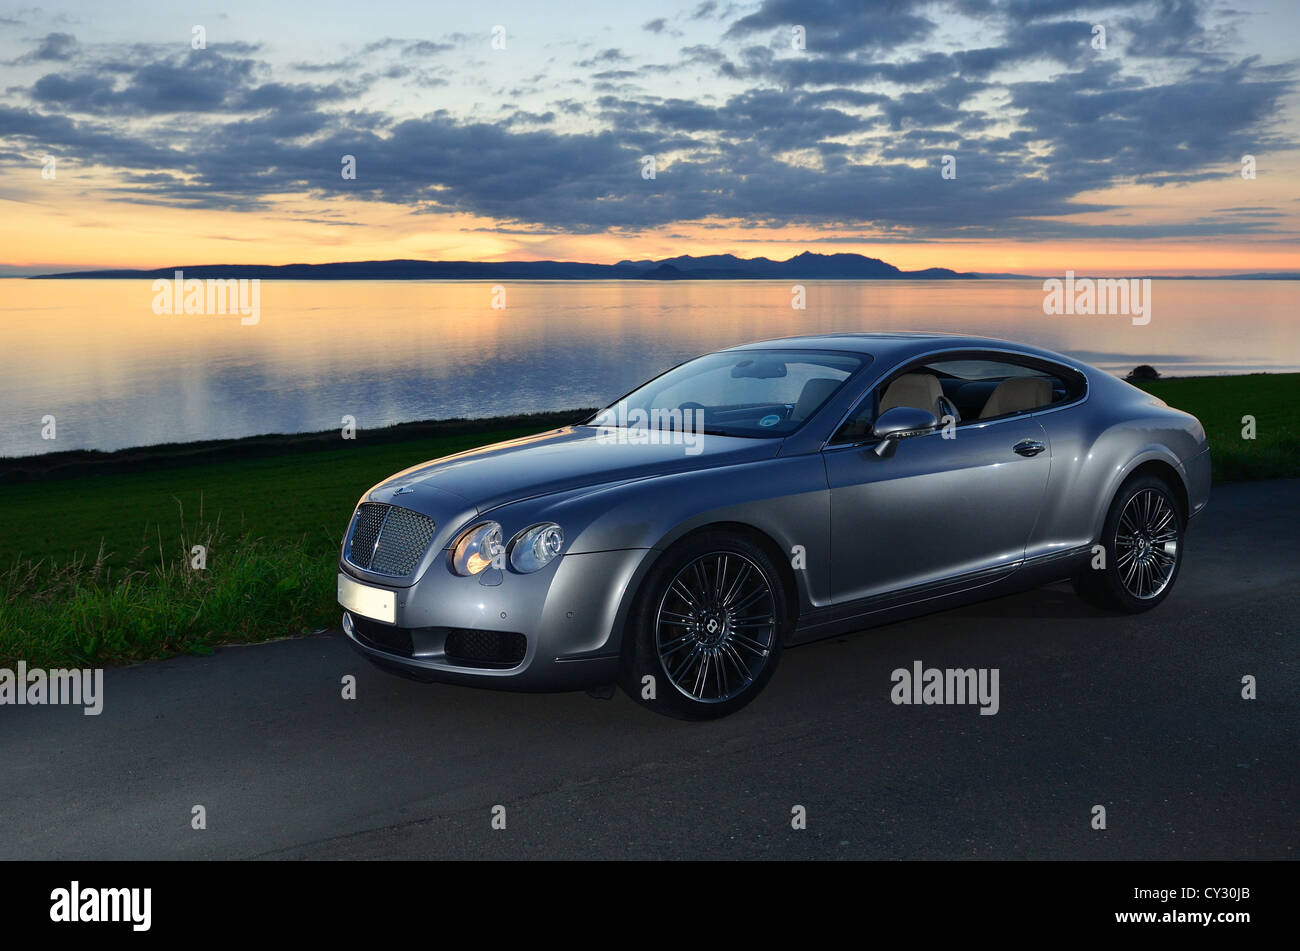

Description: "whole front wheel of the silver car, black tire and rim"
619 531 789 720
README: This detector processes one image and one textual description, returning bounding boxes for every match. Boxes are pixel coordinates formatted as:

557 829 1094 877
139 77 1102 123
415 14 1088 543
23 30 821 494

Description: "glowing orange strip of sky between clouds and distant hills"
0 161 1300 275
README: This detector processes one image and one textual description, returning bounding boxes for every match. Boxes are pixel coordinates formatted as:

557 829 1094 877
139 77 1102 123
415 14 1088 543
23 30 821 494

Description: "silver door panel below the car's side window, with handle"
823 361 1052 603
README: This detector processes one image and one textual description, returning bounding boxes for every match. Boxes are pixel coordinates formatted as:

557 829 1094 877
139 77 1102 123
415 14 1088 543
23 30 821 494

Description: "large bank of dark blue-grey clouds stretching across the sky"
0 0 1294 240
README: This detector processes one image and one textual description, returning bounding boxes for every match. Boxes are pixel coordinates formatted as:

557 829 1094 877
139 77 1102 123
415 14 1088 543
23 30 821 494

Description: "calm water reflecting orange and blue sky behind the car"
0 279 1300 456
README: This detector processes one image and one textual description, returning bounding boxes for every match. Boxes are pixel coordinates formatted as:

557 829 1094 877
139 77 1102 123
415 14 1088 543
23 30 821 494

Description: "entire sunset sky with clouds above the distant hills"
0 0 1300 275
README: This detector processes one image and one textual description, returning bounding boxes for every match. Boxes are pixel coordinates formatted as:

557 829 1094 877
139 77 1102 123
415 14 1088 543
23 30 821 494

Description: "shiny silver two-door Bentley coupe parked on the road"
338 334 1210 720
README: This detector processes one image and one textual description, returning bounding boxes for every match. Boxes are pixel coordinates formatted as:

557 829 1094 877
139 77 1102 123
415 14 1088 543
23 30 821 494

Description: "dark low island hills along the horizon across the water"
30 251 1300 281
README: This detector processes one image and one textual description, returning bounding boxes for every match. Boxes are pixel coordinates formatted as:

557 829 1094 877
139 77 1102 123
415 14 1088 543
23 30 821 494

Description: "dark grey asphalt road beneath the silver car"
0 481 1300 859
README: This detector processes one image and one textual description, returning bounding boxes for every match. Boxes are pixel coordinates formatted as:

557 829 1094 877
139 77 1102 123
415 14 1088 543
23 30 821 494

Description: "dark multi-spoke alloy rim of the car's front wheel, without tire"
655 551 776 703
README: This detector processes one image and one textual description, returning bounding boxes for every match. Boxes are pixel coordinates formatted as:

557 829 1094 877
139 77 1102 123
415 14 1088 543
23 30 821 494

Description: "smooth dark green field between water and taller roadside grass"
0 413 581 568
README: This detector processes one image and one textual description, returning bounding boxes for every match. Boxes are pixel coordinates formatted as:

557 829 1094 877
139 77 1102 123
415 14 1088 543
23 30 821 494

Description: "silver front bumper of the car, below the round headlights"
339 548 650 691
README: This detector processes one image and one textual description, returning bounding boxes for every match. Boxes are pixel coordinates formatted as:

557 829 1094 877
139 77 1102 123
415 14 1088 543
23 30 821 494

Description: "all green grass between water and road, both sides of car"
0 374 1300 668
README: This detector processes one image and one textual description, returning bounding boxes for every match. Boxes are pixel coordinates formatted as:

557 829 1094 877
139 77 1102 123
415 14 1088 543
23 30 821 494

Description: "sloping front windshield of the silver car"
588 349 871 438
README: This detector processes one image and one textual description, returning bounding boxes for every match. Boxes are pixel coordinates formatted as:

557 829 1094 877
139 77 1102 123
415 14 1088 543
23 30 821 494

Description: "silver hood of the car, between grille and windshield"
368 426 781 513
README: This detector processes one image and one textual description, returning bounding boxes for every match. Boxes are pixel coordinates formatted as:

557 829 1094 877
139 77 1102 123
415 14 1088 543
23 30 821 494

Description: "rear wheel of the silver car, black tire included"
1074 476 1187 615
